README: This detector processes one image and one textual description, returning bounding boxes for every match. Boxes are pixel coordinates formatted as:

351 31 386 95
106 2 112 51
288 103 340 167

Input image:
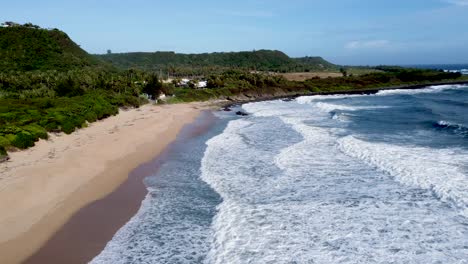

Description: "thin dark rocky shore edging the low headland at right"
222 80 468 109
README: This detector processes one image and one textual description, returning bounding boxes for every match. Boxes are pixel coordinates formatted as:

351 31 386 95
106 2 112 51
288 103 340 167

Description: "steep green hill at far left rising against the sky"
0 23 101 72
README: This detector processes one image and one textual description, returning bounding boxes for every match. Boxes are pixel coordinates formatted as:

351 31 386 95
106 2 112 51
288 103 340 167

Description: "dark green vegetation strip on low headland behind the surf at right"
165 68 461 102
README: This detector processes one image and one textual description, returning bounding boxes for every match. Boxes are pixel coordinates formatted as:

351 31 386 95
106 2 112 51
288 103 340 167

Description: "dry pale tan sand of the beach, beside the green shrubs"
0 104 204 264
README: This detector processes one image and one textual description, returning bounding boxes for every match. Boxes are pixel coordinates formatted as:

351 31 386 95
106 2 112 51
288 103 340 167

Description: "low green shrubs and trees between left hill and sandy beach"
0 67 155 153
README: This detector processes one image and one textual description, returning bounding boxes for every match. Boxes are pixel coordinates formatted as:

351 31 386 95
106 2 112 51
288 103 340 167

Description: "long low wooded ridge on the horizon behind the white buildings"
96 50 337 76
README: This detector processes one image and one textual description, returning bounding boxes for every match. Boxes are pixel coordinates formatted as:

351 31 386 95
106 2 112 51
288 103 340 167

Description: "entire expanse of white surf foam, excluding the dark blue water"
92 89 468 264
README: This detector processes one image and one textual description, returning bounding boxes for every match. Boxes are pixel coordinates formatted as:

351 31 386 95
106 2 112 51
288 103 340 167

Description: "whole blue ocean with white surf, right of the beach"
92 85 468 264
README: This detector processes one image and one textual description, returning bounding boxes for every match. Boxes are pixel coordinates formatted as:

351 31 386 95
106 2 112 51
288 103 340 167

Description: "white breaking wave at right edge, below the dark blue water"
338 136 468 217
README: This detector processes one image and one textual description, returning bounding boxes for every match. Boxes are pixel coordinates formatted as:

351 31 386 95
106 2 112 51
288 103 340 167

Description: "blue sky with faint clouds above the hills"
0 0 468 65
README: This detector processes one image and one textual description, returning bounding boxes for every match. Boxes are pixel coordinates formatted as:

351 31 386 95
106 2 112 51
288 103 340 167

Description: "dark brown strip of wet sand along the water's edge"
24 111 218 264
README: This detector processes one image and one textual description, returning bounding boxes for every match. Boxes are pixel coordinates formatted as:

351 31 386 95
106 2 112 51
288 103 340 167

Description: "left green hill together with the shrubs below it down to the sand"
0 24 150 156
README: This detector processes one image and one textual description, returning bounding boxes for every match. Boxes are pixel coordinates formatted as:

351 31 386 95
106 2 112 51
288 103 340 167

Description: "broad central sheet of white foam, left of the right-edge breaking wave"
201 102 468 263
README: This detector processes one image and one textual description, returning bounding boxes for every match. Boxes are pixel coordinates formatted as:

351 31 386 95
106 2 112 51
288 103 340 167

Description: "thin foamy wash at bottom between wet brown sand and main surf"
90 189 211 264
